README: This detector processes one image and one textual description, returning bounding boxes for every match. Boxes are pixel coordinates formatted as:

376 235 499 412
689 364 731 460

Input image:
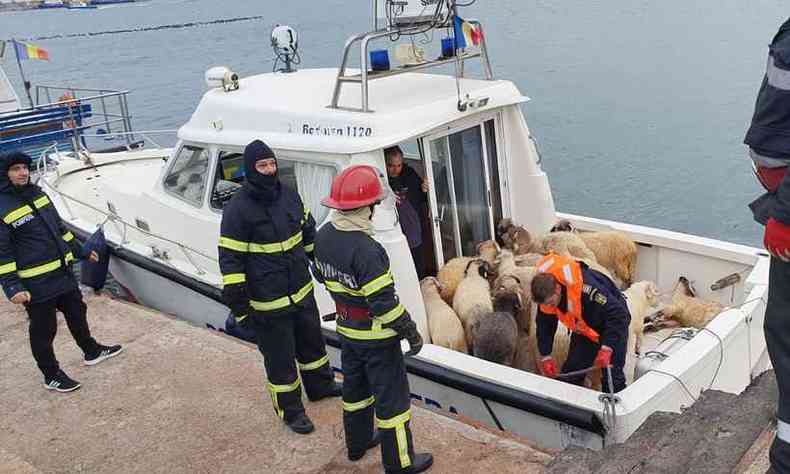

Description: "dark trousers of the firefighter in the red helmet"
341 337 414 472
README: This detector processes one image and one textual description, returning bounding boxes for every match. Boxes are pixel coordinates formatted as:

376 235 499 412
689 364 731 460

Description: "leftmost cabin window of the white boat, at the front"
163 145 209 206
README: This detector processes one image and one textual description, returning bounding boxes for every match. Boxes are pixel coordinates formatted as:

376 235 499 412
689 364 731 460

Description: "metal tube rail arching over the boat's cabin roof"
329 17 494 112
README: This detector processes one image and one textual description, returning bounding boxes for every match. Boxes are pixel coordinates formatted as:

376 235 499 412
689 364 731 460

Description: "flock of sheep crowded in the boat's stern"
420 219 724 390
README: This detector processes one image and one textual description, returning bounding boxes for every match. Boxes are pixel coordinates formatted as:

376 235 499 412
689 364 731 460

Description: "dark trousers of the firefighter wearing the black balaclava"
251 295 335 422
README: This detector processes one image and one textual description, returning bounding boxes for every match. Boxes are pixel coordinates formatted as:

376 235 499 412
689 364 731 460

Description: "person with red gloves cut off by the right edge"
744 16 790 473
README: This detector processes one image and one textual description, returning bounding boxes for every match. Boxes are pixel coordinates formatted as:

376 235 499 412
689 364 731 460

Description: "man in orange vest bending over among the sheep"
532 254 631 392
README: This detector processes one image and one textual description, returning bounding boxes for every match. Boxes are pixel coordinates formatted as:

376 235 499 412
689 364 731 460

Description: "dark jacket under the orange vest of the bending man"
536 263 631 356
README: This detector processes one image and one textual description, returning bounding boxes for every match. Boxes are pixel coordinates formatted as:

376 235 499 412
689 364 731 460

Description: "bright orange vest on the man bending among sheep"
538 253 600 343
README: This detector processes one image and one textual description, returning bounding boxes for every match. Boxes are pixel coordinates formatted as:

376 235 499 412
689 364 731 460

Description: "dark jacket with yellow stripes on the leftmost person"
0 172 81 303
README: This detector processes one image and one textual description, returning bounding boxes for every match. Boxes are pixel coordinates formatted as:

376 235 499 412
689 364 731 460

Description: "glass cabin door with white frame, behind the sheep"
422 118 502 268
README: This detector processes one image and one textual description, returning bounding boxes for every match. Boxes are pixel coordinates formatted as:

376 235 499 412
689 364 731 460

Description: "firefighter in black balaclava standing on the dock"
219 140 340 434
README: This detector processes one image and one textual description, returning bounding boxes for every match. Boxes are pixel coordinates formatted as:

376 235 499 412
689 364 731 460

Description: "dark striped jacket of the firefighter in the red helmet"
314 223 410 345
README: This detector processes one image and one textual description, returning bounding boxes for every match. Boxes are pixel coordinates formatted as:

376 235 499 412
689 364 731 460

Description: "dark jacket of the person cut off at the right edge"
744 19 790 225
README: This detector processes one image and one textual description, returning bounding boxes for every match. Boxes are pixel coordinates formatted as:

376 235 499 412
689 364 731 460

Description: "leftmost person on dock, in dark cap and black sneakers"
0 152 123 392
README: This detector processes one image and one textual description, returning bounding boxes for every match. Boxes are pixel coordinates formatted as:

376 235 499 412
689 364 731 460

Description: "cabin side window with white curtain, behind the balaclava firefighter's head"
211 152 337 223
